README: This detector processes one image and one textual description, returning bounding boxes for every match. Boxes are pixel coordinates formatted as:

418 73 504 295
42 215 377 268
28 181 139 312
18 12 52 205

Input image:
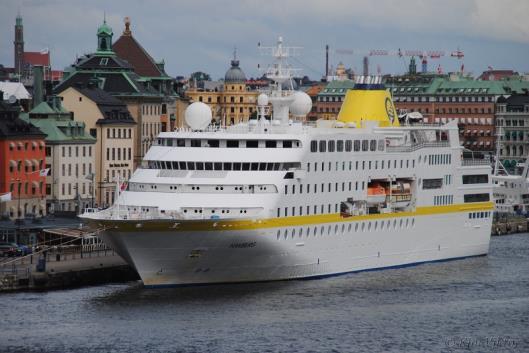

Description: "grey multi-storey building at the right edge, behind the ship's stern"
496 93 529 171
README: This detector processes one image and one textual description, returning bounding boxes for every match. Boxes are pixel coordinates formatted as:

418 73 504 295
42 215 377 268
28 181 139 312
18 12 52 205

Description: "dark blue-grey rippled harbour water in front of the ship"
0 234 529 353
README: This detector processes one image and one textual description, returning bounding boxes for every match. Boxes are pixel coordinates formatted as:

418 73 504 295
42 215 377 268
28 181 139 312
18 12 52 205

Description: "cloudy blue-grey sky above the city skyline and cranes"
0 0 529 79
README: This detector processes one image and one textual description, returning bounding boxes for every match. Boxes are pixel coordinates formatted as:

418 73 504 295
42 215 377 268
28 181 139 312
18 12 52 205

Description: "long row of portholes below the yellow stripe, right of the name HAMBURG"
276 218 415 240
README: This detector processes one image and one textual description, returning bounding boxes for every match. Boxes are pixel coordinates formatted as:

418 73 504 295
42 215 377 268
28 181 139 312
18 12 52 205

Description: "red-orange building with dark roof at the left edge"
0 96 46 218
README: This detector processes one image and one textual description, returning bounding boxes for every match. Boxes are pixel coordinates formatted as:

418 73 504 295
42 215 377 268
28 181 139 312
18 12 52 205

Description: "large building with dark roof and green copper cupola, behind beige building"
55 21 161 169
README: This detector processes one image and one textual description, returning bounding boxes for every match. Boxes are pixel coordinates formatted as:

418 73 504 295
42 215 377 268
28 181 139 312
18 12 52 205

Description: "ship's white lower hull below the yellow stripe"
99 206 492 287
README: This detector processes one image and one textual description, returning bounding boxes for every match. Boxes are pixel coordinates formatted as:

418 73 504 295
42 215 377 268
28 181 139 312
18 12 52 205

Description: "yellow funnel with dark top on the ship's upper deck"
338 83 399 127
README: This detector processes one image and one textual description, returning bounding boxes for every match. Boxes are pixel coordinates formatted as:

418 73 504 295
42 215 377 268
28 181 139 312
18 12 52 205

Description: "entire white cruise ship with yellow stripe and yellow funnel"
81 38 494 287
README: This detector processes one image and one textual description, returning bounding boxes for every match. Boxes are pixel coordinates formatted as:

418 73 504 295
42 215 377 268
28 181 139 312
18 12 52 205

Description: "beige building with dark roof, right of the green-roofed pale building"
61 81 137 206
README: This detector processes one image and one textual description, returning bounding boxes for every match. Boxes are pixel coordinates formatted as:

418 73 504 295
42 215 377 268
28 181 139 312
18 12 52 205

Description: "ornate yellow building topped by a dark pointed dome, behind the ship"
186 55 259 125
